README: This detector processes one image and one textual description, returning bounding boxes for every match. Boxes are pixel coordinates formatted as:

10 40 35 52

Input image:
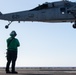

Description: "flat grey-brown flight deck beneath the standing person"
0 67 76 75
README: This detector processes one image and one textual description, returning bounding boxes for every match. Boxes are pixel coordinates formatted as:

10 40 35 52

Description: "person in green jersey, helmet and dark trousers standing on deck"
5 31 20 74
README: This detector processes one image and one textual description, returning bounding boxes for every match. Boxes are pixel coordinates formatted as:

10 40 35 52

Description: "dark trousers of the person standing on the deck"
6 50 17 72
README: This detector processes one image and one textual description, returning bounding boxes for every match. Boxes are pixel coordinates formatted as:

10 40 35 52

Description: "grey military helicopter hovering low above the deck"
0 0 76 29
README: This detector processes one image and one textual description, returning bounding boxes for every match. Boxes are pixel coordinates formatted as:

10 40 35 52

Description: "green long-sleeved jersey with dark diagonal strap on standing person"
7 37 20 51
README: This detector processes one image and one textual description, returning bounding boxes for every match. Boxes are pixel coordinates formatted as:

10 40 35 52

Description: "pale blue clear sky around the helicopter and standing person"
0 0 76 67
